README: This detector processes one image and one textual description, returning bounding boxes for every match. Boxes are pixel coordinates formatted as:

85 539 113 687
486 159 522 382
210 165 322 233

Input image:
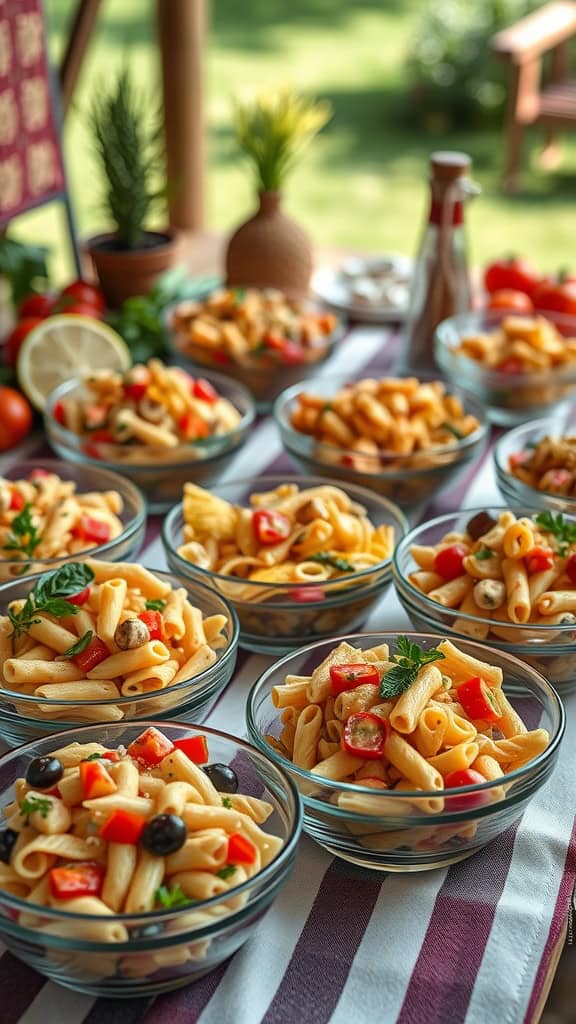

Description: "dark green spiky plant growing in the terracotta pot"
89 70 165 251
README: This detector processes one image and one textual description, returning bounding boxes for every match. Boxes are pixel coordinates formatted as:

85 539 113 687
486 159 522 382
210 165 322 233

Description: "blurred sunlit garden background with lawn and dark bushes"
12 0 576 276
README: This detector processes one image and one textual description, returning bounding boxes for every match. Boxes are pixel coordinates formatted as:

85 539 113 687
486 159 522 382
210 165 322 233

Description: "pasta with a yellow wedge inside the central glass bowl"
178 483 395 600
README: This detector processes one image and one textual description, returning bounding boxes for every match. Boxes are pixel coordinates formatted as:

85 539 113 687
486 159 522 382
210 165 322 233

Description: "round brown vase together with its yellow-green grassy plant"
225 90 331 296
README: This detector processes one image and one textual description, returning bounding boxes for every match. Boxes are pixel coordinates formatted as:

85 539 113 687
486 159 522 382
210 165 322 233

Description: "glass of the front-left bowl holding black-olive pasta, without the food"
0 721 302 998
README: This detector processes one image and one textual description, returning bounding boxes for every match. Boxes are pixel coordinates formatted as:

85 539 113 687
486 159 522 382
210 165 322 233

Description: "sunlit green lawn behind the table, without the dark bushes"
13 0 576 276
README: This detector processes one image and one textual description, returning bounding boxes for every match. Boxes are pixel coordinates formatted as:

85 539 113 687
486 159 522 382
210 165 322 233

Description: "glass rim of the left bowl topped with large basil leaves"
0 562 240 708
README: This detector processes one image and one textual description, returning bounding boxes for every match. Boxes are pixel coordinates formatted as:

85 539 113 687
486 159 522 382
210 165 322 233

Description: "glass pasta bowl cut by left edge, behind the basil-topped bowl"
0 459 147 584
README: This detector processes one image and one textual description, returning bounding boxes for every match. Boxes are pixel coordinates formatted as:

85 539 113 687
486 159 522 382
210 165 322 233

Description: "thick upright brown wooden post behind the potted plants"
157 0 206 230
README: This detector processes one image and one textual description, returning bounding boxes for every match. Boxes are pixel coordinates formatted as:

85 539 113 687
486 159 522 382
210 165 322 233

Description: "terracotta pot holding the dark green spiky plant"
85 231 179 308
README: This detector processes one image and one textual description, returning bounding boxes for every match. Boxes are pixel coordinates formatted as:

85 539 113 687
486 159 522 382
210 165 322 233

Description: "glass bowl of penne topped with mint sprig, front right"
246 633 565 871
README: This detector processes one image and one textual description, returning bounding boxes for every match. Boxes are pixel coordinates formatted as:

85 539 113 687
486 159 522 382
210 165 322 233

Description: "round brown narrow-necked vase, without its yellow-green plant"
225 191 313 297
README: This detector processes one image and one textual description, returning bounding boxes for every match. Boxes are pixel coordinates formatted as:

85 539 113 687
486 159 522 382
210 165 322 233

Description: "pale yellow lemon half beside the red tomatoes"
16 313 132 411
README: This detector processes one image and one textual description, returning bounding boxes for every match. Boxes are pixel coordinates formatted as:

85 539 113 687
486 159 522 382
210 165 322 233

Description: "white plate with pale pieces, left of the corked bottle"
312 254 413 324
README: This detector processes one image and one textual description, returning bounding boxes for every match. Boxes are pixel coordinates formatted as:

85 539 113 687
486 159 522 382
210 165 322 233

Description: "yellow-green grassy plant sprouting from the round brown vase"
234 89 332 191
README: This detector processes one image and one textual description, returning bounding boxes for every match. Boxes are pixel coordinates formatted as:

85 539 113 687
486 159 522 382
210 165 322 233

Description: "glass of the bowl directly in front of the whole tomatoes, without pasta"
435 310 576 426
